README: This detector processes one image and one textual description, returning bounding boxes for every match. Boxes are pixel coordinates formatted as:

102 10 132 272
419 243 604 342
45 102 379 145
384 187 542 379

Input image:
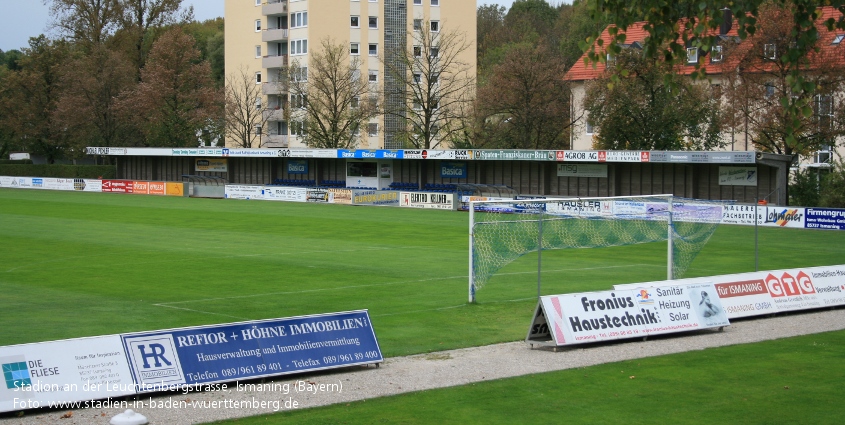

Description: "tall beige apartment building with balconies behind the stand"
225 0 476 149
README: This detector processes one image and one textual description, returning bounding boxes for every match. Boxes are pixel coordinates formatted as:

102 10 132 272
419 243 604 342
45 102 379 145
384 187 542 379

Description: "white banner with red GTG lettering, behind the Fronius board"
614 265 845 319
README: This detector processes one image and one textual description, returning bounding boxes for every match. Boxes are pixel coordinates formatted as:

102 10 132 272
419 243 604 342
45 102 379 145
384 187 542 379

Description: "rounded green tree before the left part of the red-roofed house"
584 48 722 150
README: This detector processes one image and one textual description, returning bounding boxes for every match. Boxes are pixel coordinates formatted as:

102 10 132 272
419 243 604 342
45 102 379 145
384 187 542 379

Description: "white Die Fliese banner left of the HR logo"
0 335 135 412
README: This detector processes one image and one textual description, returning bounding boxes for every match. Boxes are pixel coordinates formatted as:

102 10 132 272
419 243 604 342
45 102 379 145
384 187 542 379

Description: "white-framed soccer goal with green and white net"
469 195 725 303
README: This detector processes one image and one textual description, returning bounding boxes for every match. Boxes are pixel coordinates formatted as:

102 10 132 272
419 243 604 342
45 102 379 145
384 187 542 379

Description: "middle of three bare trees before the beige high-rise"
287 39 380 149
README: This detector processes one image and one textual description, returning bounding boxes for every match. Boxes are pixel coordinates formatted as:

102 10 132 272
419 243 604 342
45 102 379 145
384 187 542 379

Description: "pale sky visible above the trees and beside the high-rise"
0 0 513 51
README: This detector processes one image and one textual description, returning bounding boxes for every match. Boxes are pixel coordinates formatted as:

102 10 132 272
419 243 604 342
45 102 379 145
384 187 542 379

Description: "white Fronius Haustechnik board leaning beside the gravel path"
526 283 730 345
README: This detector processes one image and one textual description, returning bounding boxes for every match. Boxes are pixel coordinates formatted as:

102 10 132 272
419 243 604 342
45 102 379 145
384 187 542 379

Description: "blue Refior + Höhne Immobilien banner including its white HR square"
121 310 384 392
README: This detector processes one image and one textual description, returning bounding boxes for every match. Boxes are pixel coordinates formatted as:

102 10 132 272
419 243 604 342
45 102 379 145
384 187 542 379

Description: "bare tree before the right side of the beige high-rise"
382 21 475 149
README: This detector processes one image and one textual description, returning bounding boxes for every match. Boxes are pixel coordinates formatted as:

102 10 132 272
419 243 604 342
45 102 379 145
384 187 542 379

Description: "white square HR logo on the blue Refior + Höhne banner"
124 334 185 384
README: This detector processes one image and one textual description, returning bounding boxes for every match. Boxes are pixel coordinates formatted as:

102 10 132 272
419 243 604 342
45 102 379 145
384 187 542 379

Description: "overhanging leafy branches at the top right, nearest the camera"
582 0 845 151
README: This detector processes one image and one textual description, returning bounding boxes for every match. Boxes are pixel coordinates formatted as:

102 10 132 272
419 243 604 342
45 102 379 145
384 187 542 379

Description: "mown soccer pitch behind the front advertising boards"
0 189 845 356
